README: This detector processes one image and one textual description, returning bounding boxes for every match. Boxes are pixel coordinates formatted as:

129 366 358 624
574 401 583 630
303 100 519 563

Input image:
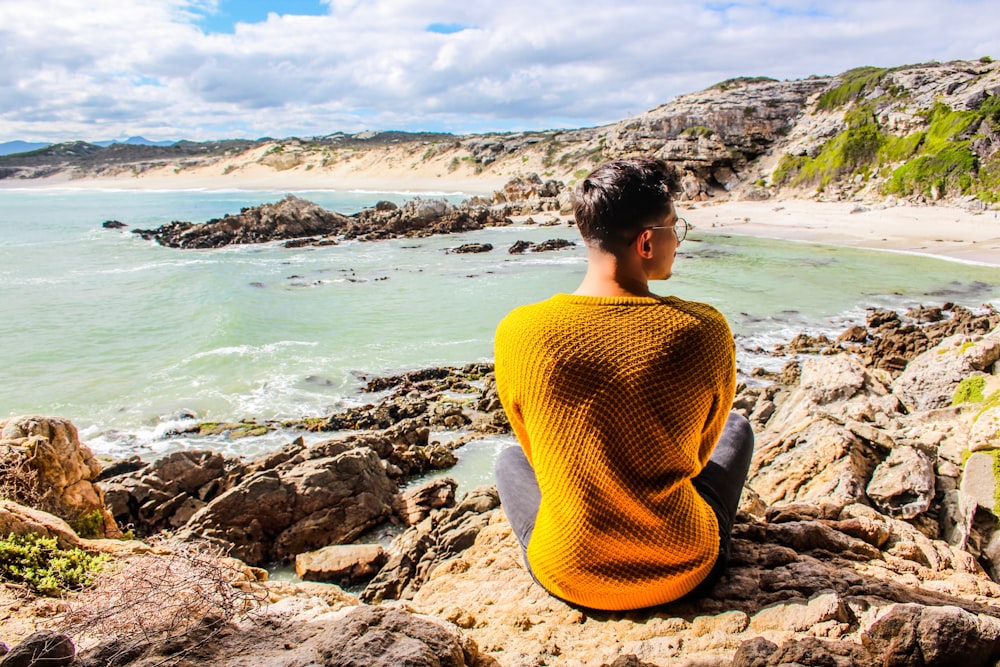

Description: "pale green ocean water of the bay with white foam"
0 189 1000 484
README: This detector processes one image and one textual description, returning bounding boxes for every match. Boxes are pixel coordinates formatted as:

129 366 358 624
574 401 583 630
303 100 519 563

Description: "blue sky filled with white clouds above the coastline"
0 0 1000 142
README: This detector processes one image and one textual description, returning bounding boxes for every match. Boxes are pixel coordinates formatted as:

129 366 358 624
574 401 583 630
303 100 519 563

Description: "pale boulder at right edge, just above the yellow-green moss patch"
892 329 1000 410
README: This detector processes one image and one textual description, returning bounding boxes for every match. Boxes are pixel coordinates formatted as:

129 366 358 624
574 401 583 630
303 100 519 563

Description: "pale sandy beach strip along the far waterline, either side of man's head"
7 167 1000 266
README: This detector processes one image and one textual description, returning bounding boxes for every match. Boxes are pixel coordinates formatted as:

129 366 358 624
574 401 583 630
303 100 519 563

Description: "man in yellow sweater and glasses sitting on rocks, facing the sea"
495 158 753 610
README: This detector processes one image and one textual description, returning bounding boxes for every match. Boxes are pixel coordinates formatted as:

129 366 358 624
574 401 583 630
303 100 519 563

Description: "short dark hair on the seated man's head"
573 157 678 252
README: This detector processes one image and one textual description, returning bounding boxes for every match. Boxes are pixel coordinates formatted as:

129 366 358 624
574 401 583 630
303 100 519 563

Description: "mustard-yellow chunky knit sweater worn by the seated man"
495 294 736 609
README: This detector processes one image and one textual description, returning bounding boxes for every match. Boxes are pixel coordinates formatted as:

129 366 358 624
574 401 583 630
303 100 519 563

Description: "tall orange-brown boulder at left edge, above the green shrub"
0 416 121 537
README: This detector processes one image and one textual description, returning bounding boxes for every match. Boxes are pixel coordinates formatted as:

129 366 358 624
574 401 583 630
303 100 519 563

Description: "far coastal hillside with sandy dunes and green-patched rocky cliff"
0 58 1000 208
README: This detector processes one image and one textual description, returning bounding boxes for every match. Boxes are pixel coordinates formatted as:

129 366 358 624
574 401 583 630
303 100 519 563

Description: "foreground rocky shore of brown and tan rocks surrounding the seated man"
0 304 1000 667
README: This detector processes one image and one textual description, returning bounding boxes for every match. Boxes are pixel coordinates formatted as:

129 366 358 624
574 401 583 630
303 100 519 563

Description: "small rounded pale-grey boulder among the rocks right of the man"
866 447 935 519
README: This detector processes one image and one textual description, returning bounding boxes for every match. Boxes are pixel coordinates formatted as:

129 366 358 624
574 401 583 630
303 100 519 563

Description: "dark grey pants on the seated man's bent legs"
493 412 753 594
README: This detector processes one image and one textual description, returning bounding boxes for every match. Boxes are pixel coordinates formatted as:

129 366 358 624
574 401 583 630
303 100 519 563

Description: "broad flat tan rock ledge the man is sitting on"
409 503 1000 667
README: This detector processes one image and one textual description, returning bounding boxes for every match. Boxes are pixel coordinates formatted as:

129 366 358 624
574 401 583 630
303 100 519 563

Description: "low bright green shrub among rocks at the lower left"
0 533 108 597
